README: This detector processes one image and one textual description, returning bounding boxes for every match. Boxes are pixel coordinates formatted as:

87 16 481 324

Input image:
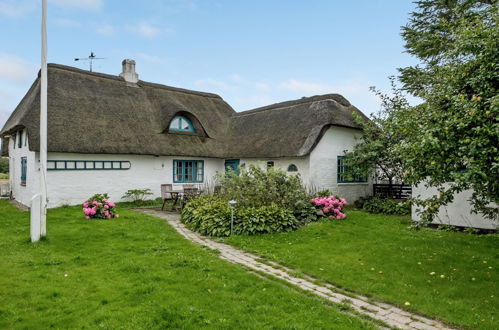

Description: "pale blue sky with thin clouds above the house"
0 0 415 127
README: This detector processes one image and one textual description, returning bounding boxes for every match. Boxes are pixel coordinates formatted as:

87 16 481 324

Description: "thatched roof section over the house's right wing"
229 94 367 157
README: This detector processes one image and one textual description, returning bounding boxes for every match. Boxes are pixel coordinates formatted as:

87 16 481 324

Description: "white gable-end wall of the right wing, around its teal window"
309 126 372 203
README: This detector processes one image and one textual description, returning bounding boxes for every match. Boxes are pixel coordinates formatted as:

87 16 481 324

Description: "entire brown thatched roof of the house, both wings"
0 64 368 158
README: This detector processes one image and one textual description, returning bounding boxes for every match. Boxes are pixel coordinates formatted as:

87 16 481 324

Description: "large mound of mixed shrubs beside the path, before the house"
181 165 346 236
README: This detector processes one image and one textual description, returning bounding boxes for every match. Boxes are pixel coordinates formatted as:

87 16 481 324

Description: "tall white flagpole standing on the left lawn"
40 0 47 237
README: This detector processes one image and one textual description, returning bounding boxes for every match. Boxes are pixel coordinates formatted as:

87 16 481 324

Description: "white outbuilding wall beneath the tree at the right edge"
412 184 497 229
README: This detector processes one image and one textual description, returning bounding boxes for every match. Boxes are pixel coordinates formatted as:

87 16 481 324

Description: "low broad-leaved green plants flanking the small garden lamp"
181 195 300 236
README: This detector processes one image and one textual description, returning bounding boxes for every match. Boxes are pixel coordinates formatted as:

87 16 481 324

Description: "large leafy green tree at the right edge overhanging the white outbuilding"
394 0 499 221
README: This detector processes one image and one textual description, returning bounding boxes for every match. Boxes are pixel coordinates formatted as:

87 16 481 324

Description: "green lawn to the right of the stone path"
224 211 499 329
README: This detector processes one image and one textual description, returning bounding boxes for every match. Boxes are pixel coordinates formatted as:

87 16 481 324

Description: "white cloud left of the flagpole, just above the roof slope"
0 53 36 84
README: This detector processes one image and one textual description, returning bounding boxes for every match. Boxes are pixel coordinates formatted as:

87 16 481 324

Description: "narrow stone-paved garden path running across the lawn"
139 209 456 329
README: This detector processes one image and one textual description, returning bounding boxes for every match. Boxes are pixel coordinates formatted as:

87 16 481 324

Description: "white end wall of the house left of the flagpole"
9 130 39 206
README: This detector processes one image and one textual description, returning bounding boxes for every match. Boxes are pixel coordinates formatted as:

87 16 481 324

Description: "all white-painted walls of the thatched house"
9 127 372 207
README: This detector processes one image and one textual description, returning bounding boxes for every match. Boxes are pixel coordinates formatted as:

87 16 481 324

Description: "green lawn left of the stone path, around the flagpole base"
0 200 373 329
